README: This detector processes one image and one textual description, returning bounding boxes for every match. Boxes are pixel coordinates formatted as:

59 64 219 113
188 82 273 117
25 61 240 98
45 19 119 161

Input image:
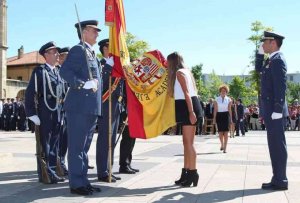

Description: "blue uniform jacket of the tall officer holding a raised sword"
60 43 102 116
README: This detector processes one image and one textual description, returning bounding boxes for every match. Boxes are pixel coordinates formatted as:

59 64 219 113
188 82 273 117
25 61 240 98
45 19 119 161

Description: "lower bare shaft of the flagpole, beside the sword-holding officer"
108 75 112 183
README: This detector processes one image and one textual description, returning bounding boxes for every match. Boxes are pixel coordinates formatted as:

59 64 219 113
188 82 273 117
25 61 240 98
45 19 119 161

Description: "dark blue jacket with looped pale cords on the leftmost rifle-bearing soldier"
25 64 62 117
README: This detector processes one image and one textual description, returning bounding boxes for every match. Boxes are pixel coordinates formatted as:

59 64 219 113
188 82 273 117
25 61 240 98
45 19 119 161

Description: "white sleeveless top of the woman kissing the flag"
174 68 197 100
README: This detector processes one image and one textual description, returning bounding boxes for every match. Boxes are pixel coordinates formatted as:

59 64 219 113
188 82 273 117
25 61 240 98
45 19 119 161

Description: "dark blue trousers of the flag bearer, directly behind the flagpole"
96 99 120 178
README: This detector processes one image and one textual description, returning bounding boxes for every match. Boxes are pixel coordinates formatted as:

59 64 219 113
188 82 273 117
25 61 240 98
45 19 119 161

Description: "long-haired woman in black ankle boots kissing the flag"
167 52 201 187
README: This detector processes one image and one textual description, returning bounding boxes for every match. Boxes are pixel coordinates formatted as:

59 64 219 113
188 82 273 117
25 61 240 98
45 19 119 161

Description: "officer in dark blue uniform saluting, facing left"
255 31 288 190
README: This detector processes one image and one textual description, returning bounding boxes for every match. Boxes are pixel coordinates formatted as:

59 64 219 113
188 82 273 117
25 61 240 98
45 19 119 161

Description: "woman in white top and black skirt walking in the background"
213 85 232 153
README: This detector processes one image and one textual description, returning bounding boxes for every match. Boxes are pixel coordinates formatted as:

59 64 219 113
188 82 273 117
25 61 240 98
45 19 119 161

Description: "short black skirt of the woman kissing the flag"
175 96 202 125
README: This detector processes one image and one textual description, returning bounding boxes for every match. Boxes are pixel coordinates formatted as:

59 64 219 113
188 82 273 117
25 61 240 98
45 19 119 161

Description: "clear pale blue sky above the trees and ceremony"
7 0 300 75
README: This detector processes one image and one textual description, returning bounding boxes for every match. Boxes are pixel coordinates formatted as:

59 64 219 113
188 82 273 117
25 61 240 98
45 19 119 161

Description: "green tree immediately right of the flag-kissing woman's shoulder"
192 63 208 101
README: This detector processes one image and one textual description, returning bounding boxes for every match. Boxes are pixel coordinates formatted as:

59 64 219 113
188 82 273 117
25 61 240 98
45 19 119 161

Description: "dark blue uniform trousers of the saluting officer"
262 100 288 187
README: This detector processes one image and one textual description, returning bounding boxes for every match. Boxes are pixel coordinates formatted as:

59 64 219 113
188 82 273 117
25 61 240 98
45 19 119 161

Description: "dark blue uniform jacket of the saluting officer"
255 52 287 113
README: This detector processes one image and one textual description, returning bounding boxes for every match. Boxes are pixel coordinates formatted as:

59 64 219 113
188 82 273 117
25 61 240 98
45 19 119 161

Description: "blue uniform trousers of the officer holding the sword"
67 111 97 188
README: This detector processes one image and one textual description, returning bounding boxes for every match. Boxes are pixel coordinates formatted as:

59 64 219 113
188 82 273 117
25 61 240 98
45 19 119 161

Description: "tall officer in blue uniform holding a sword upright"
60 20 101 195
